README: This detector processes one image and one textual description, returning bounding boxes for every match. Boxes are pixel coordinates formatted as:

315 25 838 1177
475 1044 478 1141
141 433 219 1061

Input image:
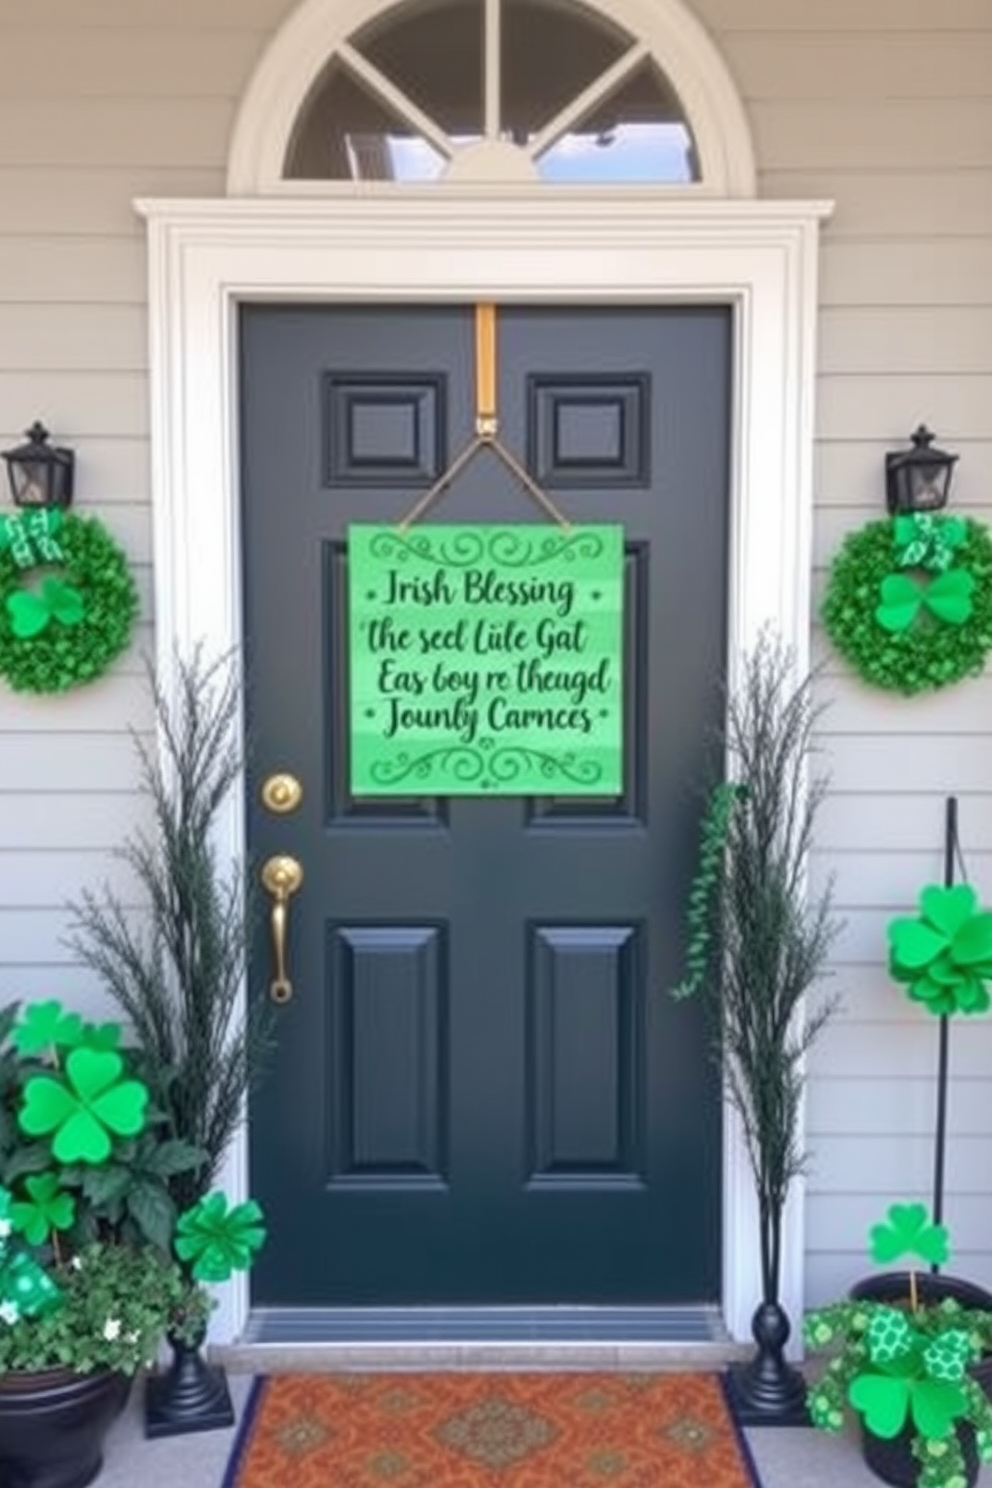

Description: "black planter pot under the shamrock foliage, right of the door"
851 1271 992 1488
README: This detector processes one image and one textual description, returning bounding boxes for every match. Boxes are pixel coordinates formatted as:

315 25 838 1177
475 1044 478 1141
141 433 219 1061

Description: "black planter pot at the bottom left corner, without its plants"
0 1369 131 1488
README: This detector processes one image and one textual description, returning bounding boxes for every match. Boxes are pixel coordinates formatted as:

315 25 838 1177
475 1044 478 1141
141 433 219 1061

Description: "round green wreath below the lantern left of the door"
0 509 138 692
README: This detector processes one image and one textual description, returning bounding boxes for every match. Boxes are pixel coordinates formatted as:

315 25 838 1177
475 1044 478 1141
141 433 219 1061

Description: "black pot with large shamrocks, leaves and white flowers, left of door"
0 1001 210 1488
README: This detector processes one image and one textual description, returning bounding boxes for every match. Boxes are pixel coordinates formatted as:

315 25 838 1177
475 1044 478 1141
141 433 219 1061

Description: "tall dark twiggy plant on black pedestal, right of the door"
675 631 839 1424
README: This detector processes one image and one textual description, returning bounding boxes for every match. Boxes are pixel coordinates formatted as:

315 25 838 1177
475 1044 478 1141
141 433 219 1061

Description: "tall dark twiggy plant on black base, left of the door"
68 649 272 1436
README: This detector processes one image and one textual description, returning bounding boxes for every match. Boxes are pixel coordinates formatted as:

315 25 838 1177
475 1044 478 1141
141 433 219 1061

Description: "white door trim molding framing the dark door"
135 183 830 1342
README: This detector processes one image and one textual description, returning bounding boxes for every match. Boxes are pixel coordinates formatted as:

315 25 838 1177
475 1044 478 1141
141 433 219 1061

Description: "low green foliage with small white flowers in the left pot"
0 1244 210 1375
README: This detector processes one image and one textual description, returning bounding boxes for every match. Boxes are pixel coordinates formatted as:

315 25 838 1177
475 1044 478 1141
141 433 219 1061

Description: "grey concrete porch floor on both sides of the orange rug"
97 1375 992 1488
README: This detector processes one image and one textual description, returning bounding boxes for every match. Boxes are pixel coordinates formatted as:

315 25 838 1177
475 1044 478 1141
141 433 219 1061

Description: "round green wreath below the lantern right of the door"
822 516 992 695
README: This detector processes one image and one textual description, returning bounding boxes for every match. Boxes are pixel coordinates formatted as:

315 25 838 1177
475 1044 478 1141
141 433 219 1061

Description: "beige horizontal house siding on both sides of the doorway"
0 0 992 1302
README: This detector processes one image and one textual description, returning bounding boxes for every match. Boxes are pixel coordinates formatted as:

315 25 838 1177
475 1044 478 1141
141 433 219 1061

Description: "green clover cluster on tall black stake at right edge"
888 884 992 1015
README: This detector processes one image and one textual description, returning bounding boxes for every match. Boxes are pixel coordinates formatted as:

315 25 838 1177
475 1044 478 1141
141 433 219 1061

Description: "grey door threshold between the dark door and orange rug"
211 1306 751 1372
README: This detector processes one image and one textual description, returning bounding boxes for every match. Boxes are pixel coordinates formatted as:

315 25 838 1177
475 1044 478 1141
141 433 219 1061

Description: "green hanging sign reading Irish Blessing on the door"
348 524 623 796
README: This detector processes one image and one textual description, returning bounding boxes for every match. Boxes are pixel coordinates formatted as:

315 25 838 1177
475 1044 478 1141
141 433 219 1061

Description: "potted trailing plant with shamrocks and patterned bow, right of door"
805 1204 992 1488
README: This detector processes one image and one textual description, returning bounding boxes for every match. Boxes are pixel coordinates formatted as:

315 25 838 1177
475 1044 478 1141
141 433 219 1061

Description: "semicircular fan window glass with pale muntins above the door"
283 0 699 186
